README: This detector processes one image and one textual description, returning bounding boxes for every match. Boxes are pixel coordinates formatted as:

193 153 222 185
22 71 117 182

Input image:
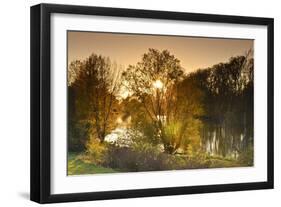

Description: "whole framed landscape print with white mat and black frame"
31 4 273 203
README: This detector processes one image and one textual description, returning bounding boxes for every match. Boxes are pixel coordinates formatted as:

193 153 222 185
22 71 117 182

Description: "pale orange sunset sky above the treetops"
67 31 254 73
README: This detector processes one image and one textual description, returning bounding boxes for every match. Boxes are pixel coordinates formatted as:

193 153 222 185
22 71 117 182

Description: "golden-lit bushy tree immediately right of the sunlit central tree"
168 73 204 152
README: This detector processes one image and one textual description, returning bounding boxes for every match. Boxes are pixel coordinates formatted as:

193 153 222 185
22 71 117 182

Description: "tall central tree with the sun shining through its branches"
122 49 187 153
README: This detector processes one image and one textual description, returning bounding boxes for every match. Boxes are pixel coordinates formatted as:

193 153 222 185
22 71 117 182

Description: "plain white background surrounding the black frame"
0 0 281 207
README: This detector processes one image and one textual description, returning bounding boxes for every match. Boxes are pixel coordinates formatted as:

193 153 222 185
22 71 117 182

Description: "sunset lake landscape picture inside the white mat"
66 30 255 176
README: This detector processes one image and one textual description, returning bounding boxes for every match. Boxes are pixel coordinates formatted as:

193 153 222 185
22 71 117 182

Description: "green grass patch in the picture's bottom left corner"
67 153 118 175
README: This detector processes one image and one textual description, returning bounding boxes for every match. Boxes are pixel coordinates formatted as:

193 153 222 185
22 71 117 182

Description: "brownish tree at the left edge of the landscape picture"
68 54 120 142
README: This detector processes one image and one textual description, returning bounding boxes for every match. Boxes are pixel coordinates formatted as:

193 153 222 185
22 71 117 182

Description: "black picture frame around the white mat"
30 4 274 203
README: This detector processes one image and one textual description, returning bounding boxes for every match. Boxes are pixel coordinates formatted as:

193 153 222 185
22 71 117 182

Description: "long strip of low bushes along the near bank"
81 130 233 172
